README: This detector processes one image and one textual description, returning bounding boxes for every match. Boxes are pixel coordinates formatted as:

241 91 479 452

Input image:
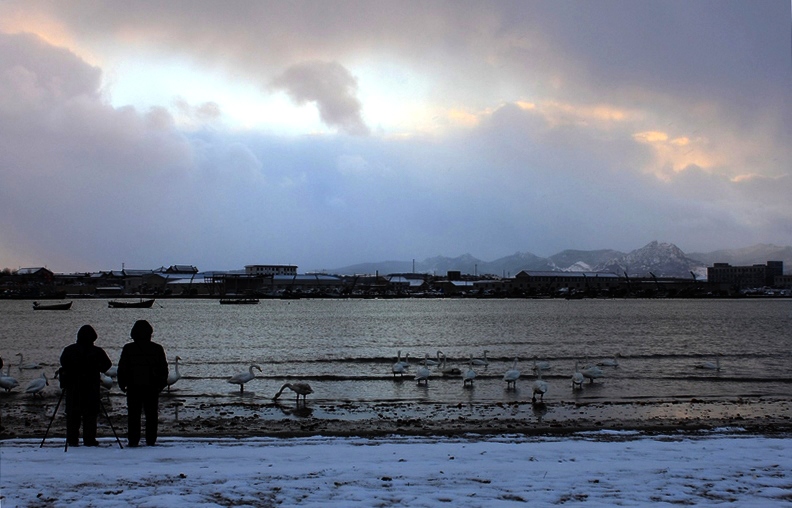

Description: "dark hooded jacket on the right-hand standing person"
118 321 168 393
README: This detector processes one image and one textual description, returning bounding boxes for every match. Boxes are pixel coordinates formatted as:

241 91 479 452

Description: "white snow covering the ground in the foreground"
0 432 792 508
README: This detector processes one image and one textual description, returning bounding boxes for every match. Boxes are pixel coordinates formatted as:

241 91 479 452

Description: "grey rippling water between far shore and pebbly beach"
0 299 792 403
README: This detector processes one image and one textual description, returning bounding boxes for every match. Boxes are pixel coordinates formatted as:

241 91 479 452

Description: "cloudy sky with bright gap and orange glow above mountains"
0 0 792 273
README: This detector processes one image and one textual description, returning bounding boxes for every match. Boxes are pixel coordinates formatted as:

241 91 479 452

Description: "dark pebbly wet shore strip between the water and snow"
0 392 792 439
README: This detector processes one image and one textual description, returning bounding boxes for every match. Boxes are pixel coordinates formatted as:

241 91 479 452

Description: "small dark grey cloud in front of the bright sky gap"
270 62 369 135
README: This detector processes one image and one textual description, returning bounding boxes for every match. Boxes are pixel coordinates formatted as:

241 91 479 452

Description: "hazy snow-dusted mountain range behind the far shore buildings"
328 241 792 279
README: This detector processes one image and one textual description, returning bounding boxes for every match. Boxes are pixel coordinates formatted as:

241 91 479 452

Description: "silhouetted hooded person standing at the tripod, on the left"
59 325 113 446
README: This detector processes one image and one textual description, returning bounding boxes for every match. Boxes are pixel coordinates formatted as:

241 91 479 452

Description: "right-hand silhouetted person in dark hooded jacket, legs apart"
118 319 168 446
